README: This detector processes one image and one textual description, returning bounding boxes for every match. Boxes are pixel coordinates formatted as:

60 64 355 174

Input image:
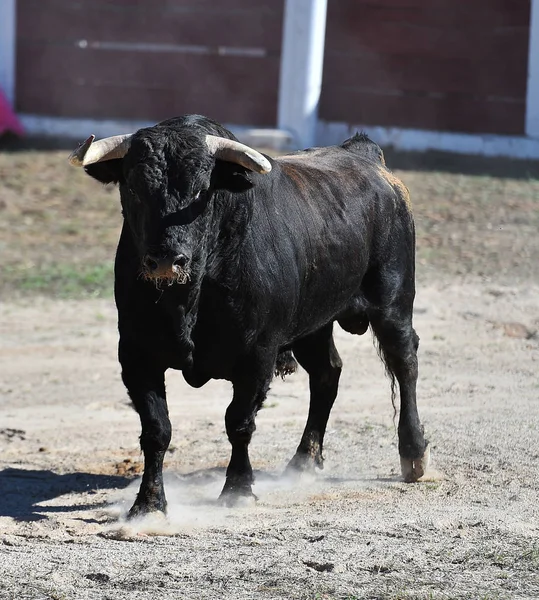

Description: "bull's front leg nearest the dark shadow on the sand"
120 342 171 518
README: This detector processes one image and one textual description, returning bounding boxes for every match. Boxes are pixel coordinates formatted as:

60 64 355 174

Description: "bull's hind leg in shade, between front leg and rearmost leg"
288 323 342 471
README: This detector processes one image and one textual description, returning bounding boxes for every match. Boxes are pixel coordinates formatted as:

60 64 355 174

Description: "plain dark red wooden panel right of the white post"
319 0 530 134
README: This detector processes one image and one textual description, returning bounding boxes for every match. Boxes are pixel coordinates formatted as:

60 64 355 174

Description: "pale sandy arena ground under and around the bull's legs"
0 280 539 600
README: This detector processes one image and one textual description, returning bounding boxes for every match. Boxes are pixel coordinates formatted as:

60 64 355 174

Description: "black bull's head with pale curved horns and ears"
69 120 271 287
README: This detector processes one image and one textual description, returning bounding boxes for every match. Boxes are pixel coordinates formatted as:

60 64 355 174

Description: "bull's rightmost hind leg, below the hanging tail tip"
370 300 429 482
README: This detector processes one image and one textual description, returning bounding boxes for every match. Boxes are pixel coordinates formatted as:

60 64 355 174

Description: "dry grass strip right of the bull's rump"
408 171 539 280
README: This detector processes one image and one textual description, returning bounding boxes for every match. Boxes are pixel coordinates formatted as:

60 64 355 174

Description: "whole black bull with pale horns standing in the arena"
71 115 429 516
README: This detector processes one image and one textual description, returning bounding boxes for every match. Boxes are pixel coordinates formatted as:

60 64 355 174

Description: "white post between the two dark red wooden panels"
277 0 327 148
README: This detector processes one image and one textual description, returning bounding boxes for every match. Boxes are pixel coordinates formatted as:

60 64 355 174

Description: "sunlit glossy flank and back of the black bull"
245 139 410 338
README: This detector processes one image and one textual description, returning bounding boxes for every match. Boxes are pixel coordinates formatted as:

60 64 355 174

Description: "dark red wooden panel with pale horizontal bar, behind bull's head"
17 0 283 126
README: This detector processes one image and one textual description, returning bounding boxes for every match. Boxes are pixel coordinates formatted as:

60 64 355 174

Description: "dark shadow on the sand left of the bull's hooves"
0 468 132 521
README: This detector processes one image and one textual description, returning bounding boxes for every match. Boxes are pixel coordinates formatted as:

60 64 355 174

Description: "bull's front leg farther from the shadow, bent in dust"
219 356 275 506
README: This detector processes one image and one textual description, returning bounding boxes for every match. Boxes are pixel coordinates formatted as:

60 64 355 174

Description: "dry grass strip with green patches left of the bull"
0 151 122 297
